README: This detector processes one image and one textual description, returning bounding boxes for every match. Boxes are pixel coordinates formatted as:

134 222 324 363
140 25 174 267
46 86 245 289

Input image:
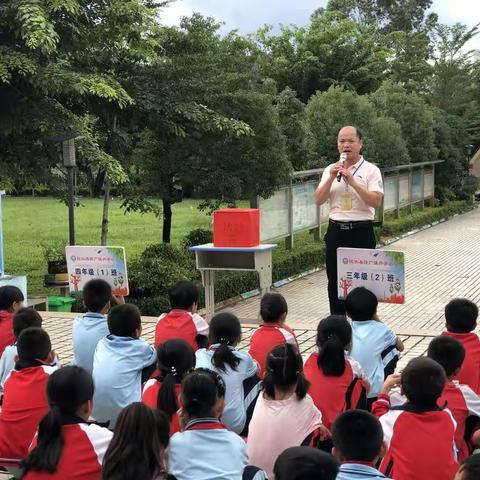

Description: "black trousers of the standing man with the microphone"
324 223 377 315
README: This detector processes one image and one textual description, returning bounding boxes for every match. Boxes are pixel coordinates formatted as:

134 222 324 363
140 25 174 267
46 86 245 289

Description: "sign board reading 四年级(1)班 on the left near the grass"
65 246 129 297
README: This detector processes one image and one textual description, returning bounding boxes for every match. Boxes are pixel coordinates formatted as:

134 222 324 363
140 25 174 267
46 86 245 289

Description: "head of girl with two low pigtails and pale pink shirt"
263 343 310 400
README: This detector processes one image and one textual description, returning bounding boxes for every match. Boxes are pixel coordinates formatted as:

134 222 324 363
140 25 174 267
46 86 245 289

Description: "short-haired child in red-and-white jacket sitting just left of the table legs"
155 280 208 351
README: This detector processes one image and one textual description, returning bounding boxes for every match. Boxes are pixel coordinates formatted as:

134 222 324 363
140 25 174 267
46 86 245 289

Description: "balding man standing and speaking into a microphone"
315 126 383 315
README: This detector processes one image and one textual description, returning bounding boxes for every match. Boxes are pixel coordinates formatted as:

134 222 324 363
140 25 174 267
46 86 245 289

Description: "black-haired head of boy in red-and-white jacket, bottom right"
400 357 446 408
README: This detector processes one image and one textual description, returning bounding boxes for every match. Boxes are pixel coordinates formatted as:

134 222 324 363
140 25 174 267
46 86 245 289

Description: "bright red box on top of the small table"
213 208 260 247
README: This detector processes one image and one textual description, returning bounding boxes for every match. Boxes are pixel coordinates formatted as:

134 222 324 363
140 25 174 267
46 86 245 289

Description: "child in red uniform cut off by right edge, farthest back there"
442 298 480 394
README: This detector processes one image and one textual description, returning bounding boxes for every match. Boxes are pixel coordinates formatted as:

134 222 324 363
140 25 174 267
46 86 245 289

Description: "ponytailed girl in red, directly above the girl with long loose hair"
142 340 195 435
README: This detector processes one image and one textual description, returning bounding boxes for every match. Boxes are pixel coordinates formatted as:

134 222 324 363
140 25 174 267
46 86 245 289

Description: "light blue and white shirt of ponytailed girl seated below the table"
195 344 258 433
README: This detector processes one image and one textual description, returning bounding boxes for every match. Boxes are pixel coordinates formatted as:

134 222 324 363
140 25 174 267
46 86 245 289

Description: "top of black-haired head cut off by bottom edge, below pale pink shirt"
273 447 340 480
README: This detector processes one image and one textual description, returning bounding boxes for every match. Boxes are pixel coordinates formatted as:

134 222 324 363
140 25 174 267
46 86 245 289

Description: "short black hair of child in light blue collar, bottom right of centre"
332 410 383 462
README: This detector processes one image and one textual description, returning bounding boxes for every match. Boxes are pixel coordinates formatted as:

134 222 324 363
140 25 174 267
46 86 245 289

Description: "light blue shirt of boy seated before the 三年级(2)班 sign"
350 320 397 398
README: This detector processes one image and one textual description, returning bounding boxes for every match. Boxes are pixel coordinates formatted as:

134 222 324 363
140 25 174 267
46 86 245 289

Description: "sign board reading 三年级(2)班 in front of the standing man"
337 248 405 303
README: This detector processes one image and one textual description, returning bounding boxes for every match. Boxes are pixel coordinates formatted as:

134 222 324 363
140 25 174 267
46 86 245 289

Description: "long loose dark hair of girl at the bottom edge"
102 402 169 480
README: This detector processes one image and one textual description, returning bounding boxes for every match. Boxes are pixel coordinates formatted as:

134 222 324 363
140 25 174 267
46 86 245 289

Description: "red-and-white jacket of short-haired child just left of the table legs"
155 309 208 351
